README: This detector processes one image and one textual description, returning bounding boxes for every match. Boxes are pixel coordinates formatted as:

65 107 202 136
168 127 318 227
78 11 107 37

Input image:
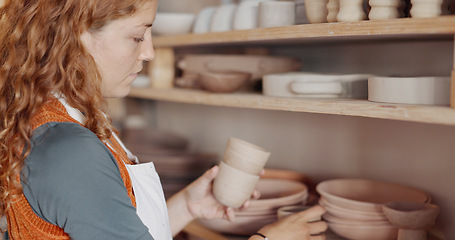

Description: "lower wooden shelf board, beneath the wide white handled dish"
129 88 455 126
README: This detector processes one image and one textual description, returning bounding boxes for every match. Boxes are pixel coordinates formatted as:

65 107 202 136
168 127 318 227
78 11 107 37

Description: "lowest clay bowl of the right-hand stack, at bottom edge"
327 222 398 240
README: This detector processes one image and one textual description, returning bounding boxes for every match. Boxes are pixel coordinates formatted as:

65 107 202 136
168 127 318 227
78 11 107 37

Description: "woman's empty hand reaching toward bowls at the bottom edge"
255 206 327 240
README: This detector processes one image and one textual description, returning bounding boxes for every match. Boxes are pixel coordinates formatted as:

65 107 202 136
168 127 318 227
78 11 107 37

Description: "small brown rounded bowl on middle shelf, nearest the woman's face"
198 71 251 93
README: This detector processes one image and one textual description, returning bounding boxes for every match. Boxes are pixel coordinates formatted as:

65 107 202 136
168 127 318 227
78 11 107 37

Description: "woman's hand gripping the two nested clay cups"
185 166 259 221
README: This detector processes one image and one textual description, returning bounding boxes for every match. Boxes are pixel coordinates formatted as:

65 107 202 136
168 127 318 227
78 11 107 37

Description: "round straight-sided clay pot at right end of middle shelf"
368 77 451 105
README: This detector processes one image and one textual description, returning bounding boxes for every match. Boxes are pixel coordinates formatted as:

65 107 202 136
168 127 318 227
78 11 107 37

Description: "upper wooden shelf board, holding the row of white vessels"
153 16 455 47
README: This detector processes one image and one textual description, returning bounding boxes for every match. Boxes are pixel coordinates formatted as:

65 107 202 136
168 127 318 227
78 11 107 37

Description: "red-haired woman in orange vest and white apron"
0 0 327 240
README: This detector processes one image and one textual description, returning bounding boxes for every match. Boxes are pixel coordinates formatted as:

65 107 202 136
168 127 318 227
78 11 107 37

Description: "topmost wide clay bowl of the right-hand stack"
316 179 430 212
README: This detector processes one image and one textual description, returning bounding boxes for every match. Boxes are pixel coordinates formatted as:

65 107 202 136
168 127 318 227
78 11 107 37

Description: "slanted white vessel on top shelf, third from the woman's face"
210 4 237 32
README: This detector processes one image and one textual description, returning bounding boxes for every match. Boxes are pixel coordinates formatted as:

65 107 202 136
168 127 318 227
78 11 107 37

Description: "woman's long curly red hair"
0 0 156 220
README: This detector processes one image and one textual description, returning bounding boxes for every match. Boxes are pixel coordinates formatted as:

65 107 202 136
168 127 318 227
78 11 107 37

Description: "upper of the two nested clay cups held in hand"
223 137 270 175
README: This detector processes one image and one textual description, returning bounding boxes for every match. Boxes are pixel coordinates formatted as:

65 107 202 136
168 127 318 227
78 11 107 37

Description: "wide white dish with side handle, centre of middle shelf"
262 72 370 99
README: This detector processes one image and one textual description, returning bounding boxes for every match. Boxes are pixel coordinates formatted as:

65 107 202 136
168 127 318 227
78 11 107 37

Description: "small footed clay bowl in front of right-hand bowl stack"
383 202 440 240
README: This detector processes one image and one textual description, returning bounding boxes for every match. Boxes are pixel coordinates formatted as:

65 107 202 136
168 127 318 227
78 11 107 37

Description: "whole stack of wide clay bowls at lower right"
316 179 431 240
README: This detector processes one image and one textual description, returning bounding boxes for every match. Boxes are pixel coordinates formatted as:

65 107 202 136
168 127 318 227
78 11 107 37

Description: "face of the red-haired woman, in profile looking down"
81 0 158 97
